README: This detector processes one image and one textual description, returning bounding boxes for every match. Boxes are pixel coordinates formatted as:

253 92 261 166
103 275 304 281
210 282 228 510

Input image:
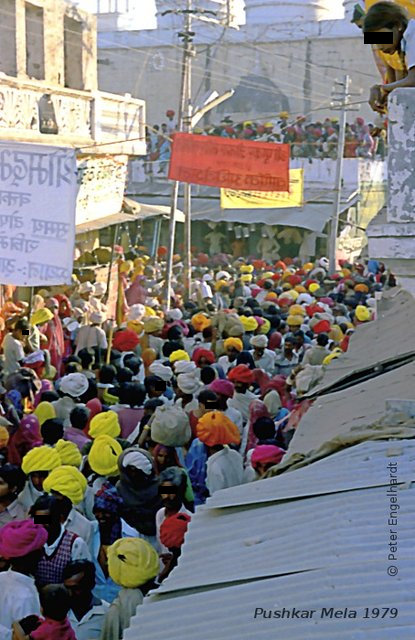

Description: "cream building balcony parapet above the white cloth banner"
0 74 146 155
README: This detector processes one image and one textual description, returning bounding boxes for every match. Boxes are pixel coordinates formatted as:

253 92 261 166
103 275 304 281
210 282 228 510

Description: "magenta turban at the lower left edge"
0 520 48 559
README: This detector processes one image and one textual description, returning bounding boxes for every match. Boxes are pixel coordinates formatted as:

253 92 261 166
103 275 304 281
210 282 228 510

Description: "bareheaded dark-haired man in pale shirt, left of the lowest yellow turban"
63 560 110 640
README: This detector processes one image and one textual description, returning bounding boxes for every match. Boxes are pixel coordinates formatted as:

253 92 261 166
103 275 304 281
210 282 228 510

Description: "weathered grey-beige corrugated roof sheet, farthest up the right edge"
308 289 415 396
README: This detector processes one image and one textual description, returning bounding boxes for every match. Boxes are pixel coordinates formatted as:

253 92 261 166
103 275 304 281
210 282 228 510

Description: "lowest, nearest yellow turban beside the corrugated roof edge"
107 538 160 589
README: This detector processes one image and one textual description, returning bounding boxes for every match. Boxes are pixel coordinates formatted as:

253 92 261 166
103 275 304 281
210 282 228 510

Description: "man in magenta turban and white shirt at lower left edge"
0 520 48 640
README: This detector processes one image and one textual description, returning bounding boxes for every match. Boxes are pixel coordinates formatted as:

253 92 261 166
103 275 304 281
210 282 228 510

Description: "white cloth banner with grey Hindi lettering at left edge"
0 142 77 286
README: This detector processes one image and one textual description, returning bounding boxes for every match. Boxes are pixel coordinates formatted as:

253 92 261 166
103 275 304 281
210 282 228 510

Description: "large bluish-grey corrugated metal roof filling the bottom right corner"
124 440 415 640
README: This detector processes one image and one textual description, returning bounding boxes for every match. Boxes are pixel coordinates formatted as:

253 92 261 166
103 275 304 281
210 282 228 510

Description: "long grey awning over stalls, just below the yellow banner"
133 192 359 233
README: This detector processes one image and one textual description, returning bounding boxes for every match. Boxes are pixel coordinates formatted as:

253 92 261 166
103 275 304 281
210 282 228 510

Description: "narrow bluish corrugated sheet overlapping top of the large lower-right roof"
207 432 415 508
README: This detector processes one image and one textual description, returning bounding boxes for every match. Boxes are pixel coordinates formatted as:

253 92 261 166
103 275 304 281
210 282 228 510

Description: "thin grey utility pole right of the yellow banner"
328 75 350 273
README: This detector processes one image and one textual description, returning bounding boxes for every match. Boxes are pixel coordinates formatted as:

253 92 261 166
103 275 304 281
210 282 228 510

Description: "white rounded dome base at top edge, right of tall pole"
245 0 344 25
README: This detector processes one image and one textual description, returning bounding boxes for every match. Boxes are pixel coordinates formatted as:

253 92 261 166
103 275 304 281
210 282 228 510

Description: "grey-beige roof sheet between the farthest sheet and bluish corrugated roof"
288 362 415 454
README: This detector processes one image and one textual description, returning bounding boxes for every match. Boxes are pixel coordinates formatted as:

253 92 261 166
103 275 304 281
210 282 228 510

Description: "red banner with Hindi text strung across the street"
169 133 290 191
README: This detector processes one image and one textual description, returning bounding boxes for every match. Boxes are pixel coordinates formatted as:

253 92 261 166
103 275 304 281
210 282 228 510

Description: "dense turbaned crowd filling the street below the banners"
0 247 395 640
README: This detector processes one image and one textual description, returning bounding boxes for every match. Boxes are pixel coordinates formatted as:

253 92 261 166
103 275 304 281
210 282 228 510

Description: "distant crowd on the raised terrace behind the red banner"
144 110 387 177
